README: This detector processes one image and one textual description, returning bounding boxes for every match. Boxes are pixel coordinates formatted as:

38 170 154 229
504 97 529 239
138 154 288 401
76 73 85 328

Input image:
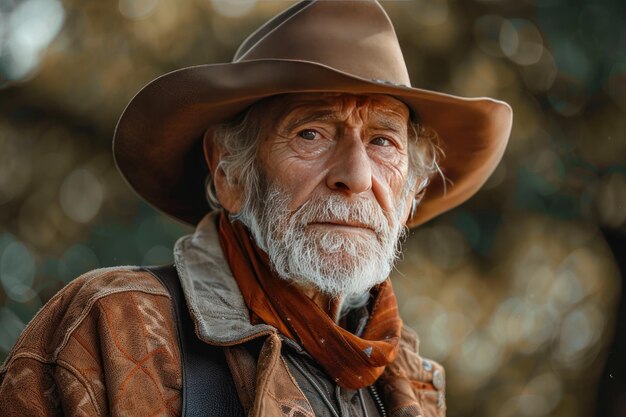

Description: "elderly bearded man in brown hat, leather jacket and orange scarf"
0 1 511 416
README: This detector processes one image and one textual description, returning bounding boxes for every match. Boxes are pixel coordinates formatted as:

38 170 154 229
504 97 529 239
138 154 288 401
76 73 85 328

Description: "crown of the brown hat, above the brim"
233 0 410 86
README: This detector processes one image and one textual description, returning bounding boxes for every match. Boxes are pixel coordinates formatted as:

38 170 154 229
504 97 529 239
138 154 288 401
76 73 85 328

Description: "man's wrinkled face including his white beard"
234 94 413 296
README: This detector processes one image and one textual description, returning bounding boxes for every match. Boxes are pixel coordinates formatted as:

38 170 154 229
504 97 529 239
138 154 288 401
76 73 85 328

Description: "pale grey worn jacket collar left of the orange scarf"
174 212 276 346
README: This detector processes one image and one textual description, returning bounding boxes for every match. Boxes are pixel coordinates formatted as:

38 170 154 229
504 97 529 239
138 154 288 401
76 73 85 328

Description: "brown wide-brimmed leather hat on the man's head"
113 0 512 226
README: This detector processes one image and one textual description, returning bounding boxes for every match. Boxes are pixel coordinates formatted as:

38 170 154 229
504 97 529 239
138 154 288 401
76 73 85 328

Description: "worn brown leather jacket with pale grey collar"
0 216 445 417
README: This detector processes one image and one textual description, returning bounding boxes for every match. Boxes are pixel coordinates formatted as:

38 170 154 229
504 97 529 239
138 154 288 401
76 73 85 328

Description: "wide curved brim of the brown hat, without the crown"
113 59 512 227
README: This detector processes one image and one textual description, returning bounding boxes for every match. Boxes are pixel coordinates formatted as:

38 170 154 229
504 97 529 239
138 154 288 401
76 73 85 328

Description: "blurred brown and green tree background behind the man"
0 0 626 417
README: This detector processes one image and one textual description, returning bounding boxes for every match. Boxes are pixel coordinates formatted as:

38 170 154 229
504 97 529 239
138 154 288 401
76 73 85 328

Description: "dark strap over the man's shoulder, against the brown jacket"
144 265 244 417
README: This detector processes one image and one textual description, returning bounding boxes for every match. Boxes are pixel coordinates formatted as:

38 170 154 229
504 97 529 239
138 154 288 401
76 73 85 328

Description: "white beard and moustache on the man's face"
234 180 406 303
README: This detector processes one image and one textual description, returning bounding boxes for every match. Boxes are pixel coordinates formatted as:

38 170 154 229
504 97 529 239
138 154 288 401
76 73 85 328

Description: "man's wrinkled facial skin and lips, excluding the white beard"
259 94 410 226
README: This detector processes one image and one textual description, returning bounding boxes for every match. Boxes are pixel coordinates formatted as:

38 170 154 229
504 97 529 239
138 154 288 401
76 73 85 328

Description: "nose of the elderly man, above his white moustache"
326 137 372 195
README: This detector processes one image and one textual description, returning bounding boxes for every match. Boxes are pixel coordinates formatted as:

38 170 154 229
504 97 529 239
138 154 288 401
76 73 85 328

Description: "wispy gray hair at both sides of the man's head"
206 98 445 210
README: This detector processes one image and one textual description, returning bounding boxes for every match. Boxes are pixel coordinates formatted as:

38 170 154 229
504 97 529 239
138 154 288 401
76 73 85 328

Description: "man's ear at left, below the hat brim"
202 129 243 213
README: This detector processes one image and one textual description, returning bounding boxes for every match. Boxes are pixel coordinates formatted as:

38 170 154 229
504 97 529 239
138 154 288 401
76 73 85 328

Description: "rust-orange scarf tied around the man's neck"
219 213 402 389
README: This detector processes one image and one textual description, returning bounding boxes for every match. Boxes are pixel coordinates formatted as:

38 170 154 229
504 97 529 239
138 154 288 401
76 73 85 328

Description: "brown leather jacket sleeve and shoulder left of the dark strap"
0 268 182 417
